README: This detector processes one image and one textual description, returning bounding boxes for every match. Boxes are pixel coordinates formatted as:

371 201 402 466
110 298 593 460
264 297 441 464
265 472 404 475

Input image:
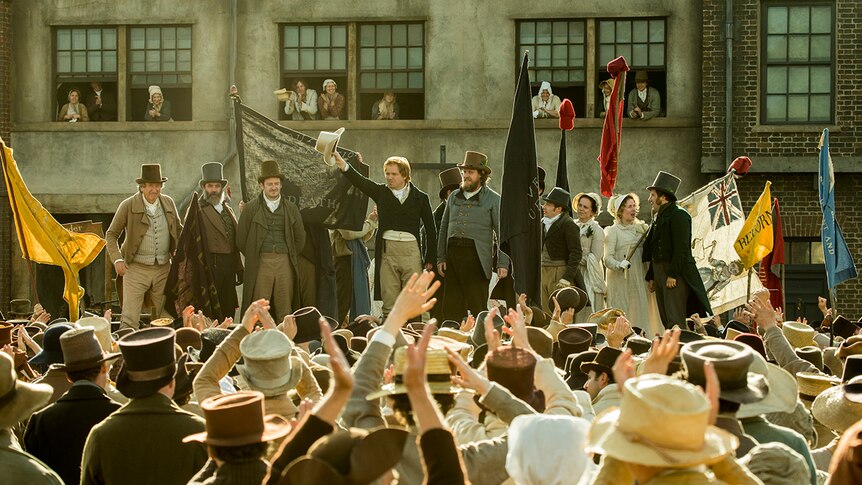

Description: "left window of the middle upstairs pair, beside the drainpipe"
279 24 351 119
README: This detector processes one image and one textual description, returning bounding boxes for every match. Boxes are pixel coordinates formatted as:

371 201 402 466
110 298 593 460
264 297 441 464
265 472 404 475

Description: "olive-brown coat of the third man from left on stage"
236 193 305 312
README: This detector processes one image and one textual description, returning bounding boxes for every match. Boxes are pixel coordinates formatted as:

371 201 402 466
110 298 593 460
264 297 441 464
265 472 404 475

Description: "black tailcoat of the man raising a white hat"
344 167 437 300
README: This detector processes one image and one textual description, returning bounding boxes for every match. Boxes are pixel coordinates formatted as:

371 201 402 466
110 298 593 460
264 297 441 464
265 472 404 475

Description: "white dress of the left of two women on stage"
575 218 607 323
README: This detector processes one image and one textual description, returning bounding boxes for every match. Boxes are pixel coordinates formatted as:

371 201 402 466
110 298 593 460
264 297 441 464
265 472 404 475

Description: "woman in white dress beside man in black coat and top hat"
604 193 664 338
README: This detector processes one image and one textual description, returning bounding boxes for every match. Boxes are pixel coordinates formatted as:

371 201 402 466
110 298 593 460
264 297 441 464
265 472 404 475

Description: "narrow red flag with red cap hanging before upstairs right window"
598 56 629 197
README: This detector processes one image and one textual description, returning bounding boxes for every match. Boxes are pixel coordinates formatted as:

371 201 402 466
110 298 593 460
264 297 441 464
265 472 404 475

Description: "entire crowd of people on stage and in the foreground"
0 147 862 485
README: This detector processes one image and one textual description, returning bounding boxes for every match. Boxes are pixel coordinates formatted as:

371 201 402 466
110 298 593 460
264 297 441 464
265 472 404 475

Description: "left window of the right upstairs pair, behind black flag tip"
515 20 586 116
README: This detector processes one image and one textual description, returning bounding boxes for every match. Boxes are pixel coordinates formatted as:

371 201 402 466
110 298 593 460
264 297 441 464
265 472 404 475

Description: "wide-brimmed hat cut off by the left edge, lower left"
0 352 54 428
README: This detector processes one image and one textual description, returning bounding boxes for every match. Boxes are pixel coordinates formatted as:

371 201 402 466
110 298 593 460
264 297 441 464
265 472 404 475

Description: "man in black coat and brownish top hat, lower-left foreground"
24 327 120 483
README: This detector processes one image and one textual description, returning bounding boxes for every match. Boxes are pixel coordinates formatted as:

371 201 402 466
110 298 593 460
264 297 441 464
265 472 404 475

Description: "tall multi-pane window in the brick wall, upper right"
761 2 834 124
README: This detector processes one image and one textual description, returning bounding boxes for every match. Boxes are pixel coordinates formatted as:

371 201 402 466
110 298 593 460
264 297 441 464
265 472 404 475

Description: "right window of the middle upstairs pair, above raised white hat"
359 23 425 119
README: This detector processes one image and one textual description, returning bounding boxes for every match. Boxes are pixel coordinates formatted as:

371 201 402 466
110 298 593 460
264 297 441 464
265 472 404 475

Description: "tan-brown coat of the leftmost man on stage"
105 192 183 264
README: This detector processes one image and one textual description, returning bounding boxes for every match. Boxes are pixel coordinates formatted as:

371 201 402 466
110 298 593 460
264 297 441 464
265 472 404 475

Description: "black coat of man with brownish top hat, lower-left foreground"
24 384 120 483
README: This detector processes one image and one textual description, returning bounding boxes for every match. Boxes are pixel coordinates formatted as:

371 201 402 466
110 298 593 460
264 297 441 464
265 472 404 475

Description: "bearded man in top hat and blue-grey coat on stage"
437 151 509 321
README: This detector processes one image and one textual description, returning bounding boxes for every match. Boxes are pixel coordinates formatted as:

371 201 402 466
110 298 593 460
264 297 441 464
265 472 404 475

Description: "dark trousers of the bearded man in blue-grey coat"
443 238 491 322
